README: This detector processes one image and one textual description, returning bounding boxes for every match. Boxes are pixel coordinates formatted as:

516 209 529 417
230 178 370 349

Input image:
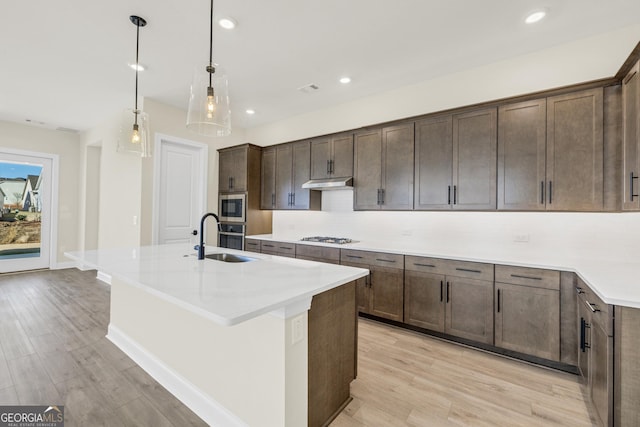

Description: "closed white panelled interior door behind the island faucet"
155 137 208 244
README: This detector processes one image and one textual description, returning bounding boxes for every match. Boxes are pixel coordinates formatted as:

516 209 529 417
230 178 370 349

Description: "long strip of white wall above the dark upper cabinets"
247 24 640 146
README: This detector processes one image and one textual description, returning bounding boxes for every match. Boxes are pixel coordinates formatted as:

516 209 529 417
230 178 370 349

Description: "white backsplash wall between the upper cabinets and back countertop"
273 190 640 267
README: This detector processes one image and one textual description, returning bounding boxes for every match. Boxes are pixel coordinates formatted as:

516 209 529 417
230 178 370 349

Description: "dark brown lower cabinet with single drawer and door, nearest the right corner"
495 265 560 361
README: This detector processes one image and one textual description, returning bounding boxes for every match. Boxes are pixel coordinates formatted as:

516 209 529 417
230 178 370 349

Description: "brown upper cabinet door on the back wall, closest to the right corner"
546 88 604 211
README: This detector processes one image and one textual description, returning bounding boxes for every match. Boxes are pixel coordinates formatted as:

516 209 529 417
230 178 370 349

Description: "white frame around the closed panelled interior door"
151 132 209 245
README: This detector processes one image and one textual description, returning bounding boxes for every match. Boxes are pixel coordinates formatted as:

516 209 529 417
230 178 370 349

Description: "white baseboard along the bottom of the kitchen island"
107 324 247 427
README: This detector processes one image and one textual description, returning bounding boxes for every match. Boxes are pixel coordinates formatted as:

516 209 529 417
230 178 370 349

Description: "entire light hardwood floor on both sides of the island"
0 269 592 427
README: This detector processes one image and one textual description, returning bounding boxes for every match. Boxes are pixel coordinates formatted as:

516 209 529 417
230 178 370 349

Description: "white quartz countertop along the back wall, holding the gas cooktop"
247 234 640 308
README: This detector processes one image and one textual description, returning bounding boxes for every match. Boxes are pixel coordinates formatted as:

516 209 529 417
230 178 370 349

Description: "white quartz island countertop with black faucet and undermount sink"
65 244 369 326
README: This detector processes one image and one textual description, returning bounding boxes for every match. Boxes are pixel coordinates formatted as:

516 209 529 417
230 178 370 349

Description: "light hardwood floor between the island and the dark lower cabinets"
331 319 597 427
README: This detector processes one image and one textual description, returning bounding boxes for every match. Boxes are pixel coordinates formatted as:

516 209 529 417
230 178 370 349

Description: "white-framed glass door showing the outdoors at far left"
0 151 53 273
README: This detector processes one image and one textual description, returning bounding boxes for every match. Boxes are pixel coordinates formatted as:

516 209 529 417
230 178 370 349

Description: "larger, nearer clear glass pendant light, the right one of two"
187 0 231 136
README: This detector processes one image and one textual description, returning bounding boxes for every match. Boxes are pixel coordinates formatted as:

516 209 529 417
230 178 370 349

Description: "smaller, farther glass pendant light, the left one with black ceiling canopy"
118 15 151 157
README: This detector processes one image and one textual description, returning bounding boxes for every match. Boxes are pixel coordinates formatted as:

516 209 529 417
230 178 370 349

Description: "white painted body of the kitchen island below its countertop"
109 278 308 427
